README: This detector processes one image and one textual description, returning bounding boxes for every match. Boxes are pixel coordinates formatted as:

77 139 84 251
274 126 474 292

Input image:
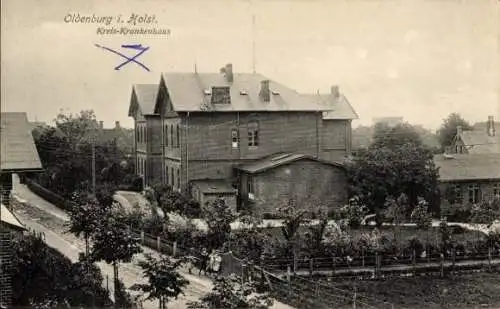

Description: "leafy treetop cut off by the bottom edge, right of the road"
188 274 273 309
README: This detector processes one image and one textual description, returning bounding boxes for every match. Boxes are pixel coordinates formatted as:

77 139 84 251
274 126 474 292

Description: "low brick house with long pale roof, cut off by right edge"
434 154 500 204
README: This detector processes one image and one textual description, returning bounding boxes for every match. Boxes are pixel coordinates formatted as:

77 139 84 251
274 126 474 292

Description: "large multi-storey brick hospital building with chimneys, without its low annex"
129 64 357 212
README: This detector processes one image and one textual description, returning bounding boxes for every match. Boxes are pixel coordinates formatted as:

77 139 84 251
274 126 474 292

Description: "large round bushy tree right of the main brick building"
348 126 438 223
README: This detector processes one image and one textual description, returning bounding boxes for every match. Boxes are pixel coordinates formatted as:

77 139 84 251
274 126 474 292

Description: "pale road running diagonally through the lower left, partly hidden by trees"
13 176 294 309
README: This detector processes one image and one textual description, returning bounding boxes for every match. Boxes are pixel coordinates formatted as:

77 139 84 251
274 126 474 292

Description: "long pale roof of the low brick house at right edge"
434 154 500 181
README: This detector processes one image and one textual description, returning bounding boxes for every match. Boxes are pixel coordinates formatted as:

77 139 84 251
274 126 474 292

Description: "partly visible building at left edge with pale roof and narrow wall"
0 113 42 306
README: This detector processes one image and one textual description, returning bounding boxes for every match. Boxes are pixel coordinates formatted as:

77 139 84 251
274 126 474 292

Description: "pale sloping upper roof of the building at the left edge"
0 113 42 171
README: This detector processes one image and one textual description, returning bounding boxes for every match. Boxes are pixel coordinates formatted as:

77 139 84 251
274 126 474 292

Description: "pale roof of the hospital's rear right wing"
304 94 359 120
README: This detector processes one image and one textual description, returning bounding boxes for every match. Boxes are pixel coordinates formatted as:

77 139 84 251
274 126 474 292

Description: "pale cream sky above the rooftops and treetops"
1 0 500 129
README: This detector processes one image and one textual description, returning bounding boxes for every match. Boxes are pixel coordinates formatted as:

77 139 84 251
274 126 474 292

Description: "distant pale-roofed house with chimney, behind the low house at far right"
448 116 500 154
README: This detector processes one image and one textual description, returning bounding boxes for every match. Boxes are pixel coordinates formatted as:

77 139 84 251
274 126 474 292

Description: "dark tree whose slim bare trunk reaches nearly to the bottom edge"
91 212 142 306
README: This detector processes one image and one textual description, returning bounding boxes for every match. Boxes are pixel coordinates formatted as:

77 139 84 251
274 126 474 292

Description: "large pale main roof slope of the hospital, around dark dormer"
162 73 331 112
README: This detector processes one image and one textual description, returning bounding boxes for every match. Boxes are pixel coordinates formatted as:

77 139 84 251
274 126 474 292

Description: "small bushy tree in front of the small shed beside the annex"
202 198 237 249
